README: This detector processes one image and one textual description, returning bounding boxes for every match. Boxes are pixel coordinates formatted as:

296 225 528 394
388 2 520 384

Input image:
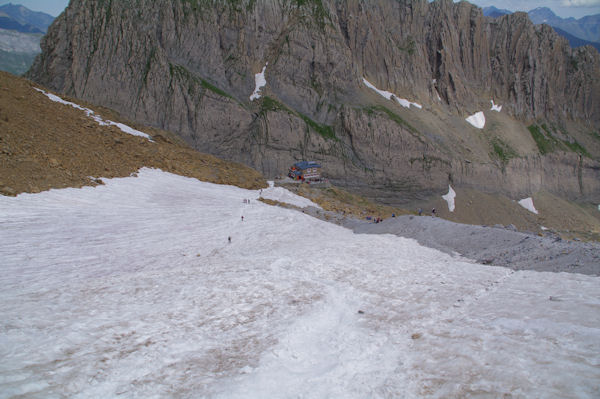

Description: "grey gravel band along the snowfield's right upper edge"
343 216 600 276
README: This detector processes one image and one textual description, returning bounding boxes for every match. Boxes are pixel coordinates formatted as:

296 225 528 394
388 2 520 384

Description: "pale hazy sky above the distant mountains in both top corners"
0 0 600 18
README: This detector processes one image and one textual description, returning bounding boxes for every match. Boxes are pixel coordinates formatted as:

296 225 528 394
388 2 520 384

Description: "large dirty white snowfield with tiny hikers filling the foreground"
0 169 600 398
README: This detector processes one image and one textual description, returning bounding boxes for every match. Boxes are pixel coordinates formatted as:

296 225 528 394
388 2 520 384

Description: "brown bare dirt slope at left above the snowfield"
0 72 267 195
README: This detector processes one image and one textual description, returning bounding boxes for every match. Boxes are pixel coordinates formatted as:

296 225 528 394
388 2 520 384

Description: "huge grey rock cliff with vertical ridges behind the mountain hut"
29 0 600 203
